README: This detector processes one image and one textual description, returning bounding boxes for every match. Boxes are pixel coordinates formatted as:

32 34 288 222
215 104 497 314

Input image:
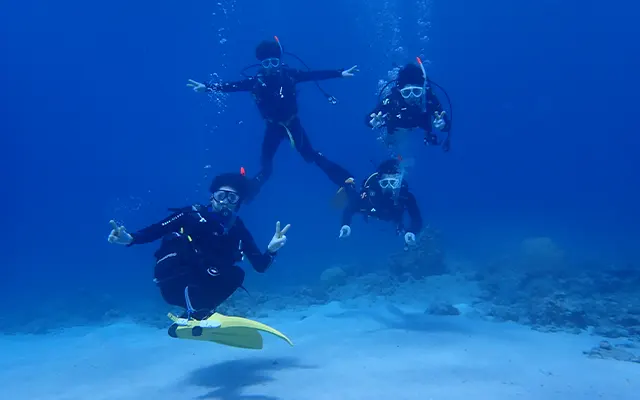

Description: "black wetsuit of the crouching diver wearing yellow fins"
130 205 275 313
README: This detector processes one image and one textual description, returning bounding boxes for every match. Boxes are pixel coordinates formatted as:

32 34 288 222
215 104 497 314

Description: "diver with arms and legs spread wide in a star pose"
187 37 358 196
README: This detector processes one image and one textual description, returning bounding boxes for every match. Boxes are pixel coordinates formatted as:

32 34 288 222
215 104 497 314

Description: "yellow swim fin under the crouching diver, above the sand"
168 313 293 350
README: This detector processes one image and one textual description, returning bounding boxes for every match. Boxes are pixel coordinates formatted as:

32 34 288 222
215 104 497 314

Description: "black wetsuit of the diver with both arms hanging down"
342 174 422 235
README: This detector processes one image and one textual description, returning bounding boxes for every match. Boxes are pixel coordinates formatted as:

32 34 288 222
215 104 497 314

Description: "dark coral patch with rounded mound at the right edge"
474 238 640 338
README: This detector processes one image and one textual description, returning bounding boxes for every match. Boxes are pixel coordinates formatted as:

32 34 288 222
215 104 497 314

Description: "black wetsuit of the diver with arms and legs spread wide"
206 67 349 194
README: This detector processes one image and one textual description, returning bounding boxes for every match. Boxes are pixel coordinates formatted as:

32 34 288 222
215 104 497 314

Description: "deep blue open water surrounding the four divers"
0 0 640 334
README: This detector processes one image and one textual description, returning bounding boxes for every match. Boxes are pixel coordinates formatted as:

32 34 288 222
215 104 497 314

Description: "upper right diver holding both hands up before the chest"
365 58 451 151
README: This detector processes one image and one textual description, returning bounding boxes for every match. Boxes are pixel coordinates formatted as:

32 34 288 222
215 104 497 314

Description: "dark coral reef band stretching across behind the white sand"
6 233 640 352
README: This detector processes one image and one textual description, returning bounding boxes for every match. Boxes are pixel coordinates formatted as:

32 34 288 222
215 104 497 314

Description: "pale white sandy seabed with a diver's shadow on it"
0 303 640 400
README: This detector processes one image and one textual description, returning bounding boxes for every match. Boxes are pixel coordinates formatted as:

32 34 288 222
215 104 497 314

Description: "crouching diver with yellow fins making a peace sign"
108 173 291 349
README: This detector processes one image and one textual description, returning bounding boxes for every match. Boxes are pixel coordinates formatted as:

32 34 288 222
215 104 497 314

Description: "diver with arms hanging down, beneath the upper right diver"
339 159 422 246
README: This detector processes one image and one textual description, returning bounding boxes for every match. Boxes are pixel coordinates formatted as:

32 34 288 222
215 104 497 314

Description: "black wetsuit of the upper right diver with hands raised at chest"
364 86 451 145
